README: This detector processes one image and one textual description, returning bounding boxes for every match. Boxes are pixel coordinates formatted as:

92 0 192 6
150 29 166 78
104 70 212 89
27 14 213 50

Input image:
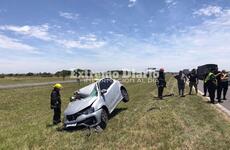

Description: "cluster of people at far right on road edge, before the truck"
203 69 228 103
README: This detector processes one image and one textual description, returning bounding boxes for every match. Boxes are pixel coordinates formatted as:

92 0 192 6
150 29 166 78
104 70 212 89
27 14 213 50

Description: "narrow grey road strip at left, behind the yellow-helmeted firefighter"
0 80 77 89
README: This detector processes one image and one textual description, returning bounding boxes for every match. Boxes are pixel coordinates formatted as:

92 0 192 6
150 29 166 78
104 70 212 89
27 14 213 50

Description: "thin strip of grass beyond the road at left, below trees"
0 77 70 85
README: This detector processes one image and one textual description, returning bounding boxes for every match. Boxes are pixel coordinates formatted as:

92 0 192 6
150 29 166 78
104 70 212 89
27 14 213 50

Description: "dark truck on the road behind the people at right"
197 64 218 80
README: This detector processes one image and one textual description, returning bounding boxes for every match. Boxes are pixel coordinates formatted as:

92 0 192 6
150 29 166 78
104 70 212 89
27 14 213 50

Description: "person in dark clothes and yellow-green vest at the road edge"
205 69 217 104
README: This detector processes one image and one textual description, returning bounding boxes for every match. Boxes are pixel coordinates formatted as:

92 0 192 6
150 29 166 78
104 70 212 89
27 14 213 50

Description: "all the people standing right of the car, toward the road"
157 68 228 103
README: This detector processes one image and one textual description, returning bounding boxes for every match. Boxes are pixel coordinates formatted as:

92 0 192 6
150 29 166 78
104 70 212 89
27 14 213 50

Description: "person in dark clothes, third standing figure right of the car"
188 69 199 95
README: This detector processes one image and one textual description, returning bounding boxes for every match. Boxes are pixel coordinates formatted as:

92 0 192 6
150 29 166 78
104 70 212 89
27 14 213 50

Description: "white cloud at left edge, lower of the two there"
0 35 37 53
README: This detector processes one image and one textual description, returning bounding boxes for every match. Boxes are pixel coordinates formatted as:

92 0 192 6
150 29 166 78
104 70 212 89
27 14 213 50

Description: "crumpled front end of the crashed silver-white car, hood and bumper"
64 84 102 128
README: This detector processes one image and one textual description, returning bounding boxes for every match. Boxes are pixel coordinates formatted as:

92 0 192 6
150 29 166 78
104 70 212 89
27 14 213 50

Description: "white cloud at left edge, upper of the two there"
0 24 51 41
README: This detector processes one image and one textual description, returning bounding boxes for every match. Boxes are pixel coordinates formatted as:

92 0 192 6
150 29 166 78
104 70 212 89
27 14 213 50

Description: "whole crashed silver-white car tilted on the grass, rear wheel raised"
64 78 129 129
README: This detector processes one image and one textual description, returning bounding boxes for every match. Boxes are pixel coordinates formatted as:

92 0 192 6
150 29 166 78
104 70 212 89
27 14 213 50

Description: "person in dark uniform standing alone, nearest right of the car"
157 68 166 99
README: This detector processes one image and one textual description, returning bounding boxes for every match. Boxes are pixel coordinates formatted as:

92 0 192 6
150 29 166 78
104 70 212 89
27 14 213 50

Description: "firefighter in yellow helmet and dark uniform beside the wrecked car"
50 84 62 125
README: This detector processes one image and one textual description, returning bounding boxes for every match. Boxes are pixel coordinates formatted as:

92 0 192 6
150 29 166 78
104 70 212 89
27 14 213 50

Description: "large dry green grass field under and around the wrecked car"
0 77 230 150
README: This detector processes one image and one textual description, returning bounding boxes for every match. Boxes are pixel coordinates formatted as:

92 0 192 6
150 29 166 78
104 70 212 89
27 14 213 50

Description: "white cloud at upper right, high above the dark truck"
193 5 223 16
